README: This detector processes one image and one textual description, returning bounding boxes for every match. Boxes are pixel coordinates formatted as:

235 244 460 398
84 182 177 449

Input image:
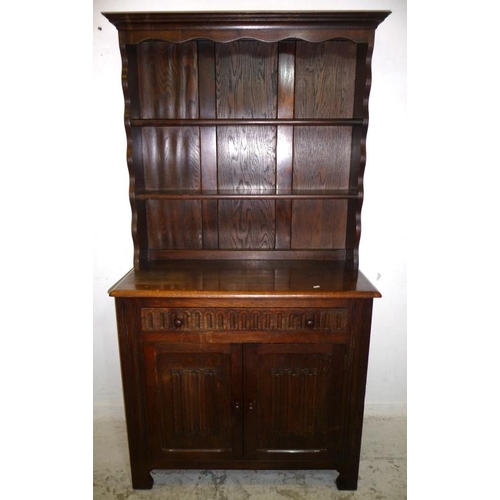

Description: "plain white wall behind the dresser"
91 0 407 413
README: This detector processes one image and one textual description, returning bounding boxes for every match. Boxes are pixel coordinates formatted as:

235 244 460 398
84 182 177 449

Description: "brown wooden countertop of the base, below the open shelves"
109 260 381 299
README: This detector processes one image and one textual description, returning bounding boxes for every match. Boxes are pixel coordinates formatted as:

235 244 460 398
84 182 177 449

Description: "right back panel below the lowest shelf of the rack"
291 200 347 250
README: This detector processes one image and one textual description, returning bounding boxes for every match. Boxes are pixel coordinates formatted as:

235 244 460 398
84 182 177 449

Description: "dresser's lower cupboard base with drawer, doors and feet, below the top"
116 298 372 490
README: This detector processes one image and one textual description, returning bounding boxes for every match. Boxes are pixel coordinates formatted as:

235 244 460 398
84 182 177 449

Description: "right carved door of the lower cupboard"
244 344 346 460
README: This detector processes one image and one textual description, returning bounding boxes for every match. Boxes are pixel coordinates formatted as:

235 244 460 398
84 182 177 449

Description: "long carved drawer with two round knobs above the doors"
141 307 348 332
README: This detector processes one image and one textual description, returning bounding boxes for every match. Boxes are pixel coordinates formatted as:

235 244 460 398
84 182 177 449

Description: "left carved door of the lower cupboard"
144 341 243 460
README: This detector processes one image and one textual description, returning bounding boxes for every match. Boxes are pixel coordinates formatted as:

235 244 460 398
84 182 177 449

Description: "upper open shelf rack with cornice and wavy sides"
108 8 387 269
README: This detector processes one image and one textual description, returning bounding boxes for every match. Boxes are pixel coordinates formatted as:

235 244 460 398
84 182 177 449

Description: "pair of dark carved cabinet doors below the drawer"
144 342 345 461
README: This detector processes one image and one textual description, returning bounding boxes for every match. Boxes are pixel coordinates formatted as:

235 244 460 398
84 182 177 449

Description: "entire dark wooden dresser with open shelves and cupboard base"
104 11 389 489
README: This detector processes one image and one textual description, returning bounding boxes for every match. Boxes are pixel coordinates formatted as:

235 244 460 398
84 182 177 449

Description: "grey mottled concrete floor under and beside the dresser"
94 410 407 500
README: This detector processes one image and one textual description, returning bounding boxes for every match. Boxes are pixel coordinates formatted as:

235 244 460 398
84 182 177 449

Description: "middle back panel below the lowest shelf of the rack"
219 200 275 250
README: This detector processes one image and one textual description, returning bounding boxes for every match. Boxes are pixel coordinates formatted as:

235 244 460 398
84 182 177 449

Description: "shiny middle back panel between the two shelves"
217 127 276 192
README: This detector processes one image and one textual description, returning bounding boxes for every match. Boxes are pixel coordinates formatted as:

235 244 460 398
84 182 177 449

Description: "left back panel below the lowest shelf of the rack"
146 200 202 249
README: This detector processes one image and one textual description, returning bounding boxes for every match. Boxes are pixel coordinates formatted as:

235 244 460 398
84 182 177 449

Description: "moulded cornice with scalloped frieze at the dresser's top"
103 11 390 44
